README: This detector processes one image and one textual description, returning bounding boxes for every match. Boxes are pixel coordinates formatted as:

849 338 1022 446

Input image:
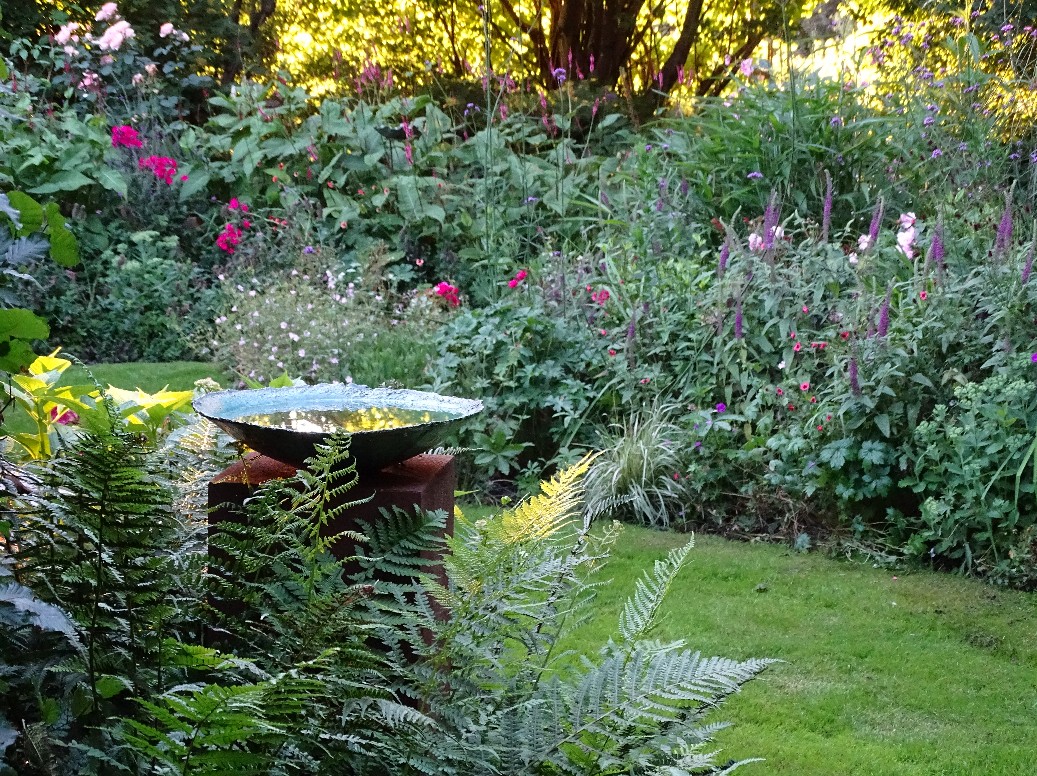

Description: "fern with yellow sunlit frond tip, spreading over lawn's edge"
369 461 769 774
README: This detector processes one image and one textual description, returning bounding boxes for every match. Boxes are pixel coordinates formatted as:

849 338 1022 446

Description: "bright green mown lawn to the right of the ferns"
569 527 1037 776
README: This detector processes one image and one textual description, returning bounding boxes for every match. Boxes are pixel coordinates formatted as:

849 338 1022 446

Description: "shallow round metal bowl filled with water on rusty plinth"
193 383 482 471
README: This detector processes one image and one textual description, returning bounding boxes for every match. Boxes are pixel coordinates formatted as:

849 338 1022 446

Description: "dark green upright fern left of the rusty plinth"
12 405 178 709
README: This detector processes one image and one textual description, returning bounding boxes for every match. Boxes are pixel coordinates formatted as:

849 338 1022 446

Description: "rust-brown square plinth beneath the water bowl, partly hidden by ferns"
208 452 457 576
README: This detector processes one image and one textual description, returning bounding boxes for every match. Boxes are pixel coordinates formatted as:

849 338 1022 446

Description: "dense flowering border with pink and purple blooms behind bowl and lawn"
6 7 1037 587
